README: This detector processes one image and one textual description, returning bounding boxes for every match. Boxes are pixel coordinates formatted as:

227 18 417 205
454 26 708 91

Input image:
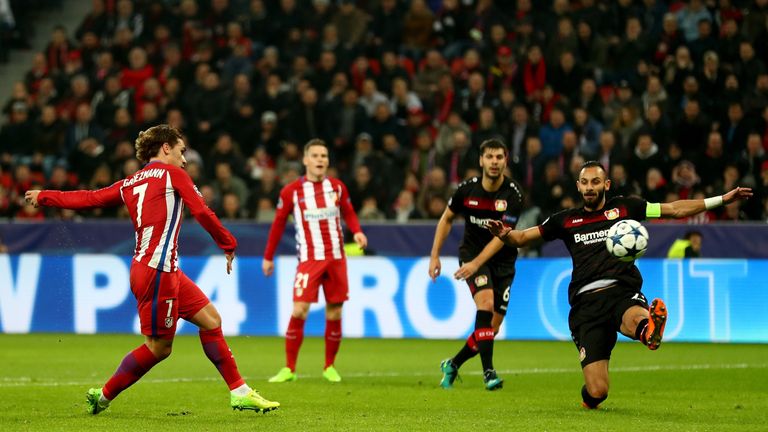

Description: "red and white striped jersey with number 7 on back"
38 162 237 272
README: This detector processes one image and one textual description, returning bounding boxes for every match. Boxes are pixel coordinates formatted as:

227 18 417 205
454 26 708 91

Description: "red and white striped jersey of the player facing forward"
264 176 362 262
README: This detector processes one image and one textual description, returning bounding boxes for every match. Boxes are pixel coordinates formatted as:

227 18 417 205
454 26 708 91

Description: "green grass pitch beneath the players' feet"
0 334 768 432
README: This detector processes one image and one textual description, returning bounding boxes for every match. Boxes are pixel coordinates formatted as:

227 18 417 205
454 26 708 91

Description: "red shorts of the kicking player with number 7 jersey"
131 261 210 339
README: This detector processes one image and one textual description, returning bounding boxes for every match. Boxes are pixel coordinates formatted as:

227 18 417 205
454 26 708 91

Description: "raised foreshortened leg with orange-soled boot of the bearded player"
620 293 667 350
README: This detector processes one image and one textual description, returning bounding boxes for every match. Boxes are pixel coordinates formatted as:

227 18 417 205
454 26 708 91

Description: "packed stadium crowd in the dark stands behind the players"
0 0 768 226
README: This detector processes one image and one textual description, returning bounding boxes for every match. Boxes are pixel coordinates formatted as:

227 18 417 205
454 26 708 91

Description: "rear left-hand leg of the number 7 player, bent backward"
86 263 178 414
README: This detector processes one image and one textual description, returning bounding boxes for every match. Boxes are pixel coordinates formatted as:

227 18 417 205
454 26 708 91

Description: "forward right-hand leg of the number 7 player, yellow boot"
178 271 280 411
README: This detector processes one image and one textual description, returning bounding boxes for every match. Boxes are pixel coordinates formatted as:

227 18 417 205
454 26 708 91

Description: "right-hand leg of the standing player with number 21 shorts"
322 259 349 382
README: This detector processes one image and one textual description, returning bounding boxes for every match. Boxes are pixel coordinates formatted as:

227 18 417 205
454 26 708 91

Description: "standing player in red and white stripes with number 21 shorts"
262 139 368 382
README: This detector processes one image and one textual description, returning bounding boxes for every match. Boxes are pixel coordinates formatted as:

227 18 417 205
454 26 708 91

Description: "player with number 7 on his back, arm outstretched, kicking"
25 125 280 414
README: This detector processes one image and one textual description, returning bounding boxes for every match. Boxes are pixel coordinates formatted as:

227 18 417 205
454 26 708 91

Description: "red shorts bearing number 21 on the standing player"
293 259 349 303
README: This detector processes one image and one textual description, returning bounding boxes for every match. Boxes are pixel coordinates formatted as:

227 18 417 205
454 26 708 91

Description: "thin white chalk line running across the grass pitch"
0 363 768 388
